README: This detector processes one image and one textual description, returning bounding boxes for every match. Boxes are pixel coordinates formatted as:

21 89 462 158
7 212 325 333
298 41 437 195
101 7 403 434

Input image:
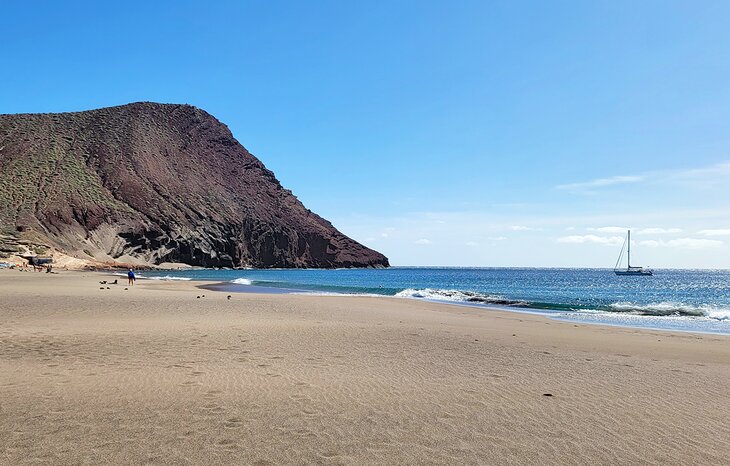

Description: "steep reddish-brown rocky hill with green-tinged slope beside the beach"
0 103 388 267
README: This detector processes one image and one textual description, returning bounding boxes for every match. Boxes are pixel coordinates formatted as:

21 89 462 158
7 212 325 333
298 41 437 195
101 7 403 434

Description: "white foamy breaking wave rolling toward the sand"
395 288 730 321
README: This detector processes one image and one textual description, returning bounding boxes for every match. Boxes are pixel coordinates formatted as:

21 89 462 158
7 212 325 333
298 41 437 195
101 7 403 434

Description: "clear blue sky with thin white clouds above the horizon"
0 0 730 268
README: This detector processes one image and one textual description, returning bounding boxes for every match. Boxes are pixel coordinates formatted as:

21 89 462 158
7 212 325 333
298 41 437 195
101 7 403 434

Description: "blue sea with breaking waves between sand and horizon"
141 267 730 334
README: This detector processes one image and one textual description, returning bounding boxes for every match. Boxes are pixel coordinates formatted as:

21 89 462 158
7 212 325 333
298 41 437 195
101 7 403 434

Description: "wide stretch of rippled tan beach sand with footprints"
0 270 730 464
